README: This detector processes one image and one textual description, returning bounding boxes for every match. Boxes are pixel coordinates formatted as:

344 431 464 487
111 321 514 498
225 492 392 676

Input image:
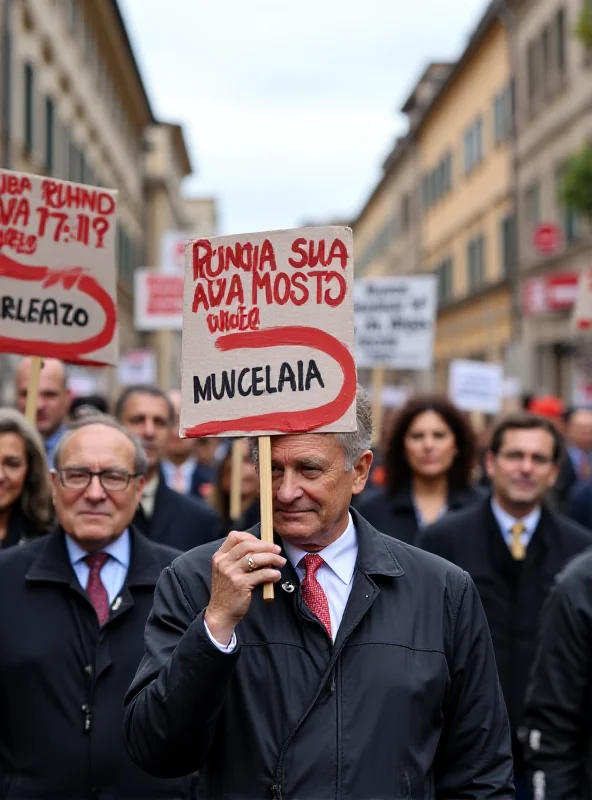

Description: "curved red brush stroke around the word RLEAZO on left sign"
0 253 117 365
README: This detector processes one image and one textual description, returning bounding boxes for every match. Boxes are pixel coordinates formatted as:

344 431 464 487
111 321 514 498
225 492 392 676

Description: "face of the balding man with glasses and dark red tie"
52 424 144 553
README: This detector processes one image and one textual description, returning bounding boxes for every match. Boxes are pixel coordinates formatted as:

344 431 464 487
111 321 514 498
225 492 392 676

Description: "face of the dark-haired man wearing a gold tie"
487 428 559 513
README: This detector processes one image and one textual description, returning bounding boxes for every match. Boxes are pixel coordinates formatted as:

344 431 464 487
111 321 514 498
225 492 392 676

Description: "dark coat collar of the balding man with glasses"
26 526 162 586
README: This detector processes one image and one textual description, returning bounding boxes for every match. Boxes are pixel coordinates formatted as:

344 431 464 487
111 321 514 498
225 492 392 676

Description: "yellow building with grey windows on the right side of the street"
413 4 515 390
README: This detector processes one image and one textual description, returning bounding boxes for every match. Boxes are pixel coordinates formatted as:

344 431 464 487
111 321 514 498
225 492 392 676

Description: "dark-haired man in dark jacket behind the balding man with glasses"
115 384 221 550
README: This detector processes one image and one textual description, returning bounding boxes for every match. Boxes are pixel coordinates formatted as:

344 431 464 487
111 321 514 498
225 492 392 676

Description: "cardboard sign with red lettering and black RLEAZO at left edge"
0 170 118 365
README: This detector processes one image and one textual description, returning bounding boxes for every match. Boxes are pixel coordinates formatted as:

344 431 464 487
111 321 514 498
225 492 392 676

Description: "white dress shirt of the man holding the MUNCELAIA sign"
204 514 358 653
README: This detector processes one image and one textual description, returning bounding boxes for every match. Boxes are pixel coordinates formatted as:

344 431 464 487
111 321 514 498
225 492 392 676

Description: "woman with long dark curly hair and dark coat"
356 395 483 544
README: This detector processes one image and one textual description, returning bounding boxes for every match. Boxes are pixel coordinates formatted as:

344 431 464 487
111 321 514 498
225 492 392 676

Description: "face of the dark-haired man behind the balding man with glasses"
120 392 171 477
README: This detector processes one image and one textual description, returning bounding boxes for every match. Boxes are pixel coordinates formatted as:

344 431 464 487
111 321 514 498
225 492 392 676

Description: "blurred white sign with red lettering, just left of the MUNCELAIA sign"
134 268 183 331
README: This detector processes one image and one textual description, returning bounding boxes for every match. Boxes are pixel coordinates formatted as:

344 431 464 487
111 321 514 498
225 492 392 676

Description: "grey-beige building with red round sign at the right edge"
511 0 592 402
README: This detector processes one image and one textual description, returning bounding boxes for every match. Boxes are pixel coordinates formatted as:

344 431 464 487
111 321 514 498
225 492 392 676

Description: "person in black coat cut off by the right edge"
526 550 592 800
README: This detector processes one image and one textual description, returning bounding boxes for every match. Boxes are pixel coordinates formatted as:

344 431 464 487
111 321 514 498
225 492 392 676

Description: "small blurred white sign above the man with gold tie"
448 360 504 414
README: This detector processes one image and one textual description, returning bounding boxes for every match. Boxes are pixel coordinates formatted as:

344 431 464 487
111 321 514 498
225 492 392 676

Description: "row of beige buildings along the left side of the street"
0 0 204 402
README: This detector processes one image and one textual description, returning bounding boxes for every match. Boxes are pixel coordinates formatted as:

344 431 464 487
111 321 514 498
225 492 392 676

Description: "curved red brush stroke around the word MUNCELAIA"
184 325 356 438
